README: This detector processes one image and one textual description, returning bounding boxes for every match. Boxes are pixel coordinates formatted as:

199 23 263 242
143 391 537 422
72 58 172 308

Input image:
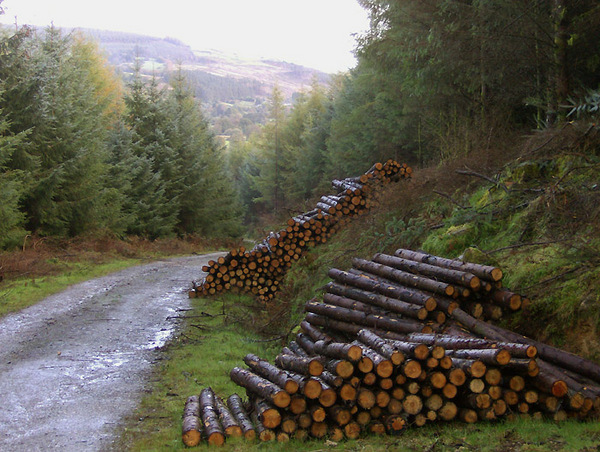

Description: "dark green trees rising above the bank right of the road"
230 0 600 221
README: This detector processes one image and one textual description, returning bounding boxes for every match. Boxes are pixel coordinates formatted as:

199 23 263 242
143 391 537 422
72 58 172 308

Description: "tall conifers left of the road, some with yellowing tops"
0 27 241 248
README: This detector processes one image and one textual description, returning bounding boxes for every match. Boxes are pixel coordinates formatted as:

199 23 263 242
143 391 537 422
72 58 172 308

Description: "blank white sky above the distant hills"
0 0 368 72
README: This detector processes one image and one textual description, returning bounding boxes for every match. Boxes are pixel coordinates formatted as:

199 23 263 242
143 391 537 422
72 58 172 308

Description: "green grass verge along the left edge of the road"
0 259 140 317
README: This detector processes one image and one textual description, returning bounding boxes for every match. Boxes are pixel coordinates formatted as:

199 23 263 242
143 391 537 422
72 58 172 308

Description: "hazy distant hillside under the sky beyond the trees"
81 29 329 135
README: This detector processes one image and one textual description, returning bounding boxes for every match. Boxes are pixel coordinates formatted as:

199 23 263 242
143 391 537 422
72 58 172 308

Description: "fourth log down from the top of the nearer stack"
327 268 437 311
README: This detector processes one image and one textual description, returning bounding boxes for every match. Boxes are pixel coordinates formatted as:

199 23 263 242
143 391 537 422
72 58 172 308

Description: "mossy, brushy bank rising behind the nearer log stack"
281 122 600 362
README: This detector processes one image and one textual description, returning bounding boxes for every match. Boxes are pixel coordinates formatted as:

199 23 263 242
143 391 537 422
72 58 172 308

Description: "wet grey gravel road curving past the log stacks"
0 254 224 452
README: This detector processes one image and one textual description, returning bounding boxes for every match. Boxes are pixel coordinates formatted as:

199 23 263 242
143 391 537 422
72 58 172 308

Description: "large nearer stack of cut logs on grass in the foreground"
183 249 600 445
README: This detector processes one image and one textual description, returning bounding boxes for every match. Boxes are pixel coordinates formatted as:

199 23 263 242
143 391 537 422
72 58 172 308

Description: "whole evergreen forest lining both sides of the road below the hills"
0 0 600 249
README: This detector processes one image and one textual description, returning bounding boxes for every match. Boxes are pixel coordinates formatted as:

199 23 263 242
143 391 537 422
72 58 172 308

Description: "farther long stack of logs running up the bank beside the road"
190 160 412 300
